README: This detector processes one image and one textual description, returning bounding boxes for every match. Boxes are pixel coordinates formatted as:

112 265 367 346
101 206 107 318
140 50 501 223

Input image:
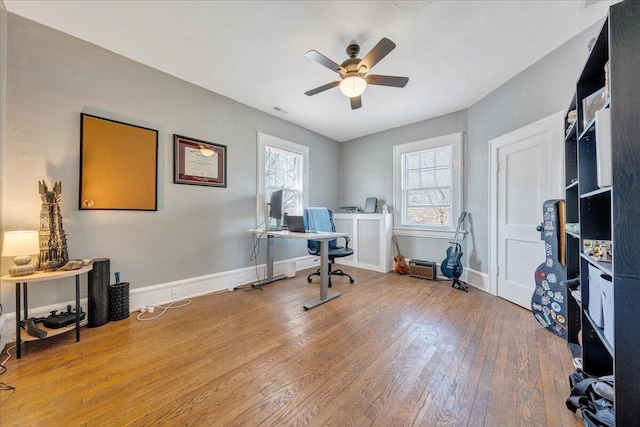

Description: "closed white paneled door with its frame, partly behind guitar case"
491 114 564 309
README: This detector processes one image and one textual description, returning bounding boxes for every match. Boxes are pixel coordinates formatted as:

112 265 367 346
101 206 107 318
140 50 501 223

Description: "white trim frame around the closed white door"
489 110 565 296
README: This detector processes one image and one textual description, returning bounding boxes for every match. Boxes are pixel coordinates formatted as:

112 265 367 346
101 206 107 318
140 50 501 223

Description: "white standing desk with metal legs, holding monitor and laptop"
247 229 347 310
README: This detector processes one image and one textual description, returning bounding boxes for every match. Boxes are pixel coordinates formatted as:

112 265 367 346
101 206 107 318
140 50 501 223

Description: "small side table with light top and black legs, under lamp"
0 265 93 359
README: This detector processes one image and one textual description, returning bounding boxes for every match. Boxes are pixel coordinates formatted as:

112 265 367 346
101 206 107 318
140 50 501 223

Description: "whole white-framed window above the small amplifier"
393 133 463 238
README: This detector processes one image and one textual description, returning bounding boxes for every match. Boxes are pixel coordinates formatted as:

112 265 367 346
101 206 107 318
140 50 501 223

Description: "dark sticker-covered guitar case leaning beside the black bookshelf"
531 200 567 338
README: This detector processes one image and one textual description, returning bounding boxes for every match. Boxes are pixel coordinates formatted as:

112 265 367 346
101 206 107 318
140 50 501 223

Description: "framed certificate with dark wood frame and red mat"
173 134 227 187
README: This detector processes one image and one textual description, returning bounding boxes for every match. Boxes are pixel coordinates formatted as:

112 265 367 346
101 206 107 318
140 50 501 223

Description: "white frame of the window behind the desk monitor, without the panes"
256 132 309 226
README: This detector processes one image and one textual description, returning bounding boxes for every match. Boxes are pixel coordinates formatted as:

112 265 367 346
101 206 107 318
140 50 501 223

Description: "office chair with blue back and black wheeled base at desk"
303 208 354 287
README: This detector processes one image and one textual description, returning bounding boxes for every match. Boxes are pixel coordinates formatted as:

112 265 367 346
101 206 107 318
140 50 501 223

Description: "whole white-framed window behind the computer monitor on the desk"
257 133 309 229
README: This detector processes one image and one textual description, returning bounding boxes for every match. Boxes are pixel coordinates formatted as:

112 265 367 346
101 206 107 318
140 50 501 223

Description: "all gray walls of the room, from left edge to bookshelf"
0 11 600 318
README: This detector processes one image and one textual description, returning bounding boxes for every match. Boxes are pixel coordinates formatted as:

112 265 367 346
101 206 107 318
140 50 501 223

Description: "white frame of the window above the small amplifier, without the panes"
393 132 464 239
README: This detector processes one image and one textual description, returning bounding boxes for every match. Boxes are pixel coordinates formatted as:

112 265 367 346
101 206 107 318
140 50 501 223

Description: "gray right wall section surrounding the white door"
466 19 602 273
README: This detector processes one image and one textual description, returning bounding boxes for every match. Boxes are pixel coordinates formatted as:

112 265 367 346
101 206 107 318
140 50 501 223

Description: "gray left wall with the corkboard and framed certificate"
1 13 340 310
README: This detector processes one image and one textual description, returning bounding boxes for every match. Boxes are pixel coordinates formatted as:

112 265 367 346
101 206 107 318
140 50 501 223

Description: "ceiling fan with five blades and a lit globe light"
304 37 409 110
